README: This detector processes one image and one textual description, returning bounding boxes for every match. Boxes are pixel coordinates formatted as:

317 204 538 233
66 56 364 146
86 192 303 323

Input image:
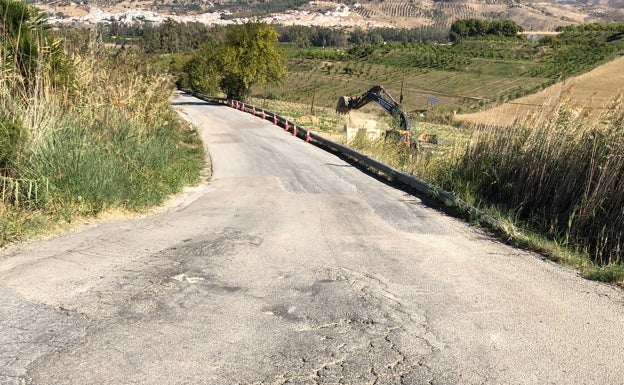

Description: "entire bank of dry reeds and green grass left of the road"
0 0 203 246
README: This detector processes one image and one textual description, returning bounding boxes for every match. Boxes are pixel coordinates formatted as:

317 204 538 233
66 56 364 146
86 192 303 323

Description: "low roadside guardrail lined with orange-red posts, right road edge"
182 90 501 229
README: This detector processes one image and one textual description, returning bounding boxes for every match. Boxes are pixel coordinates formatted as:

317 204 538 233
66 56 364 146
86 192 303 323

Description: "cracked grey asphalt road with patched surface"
0 91 624 385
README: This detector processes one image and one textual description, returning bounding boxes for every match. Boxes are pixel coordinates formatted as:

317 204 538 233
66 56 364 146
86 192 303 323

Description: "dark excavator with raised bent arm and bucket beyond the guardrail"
336 86 412 146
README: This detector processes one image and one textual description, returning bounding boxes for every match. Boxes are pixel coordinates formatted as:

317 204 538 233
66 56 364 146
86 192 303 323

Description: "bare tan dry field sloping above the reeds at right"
455 57 624 127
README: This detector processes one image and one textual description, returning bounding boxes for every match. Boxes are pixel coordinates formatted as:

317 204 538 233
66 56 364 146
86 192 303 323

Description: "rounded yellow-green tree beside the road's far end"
187 21 286 100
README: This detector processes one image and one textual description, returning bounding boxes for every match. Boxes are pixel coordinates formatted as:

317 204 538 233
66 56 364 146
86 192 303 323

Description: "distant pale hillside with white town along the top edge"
35 0 624 31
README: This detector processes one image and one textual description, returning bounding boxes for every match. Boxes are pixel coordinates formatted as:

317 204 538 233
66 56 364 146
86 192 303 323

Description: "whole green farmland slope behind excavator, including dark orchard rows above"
253 31 624 116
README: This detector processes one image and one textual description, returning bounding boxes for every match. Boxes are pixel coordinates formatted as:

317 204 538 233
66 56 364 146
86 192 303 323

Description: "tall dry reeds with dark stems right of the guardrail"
351 95 624 270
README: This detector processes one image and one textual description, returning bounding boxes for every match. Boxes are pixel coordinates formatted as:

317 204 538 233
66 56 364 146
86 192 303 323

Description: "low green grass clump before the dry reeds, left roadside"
29 108 203 214
